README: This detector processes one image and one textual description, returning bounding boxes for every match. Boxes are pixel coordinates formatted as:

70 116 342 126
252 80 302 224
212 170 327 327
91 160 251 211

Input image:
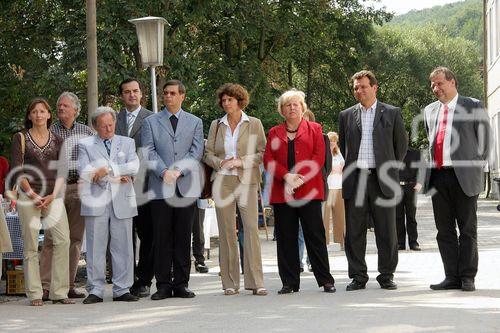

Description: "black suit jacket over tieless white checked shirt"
339 101 408 199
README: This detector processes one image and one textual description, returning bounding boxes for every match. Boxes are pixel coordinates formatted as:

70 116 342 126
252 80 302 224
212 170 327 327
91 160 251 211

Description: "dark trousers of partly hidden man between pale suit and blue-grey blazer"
133 202 154 287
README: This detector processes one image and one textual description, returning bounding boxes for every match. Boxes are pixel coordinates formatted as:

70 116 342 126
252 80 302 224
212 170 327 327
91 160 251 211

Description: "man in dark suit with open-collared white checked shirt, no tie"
339 71 408 291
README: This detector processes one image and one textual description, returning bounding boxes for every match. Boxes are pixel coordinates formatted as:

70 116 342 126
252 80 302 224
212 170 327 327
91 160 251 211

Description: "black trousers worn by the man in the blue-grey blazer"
150 198 196 290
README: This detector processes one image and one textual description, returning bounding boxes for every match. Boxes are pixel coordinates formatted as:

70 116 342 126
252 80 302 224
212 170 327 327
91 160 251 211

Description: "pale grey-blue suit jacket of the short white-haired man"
78 135 139 219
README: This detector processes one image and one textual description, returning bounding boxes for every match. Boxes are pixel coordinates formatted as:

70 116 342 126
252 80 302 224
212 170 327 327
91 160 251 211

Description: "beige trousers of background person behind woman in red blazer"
323 189 345 247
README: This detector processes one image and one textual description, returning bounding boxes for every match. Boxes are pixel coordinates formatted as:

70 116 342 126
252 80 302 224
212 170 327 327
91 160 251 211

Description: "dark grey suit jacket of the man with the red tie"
424 95 491 197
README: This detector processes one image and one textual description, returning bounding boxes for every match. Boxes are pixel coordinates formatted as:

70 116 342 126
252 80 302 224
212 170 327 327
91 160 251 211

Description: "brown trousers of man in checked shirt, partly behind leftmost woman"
40 184 85 290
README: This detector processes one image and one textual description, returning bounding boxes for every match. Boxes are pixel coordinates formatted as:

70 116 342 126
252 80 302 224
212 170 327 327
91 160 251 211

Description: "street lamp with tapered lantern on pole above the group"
129 16 168 113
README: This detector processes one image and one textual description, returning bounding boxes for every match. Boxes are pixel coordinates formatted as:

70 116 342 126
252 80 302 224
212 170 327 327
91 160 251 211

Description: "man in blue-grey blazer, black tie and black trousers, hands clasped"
142 80 204 300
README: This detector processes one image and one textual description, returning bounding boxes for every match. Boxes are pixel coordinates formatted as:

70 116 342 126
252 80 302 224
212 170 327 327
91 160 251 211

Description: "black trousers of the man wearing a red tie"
430 169 478 279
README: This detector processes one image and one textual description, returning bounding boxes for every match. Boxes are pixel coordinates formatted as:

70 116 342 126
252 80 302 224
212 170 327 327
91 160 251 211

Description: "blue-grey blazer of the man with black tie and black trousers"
142 109 204 199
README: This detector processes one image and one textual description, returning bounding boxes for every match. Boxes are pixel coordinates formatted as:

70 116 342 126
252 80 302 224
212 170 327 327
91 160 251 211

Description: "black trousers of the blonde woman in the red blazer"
273 200 335 289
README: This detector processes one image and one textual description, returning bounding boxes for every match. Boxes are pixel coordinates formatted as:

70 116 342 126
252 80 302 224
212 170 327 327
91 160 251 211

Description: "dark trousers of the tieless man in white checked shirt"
344 171 398 283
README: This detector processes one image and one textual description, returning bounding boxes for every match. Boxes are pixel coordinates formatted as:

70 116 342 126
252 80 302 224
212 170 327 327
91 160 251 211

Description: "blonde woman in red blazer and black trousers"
264 90 335 294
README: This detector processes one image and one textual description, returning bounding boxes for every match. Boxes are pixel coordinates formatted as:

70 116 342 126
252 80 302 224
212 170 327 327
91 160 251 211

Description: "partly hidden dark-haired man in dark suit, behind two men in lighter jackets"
115 78 154 297
